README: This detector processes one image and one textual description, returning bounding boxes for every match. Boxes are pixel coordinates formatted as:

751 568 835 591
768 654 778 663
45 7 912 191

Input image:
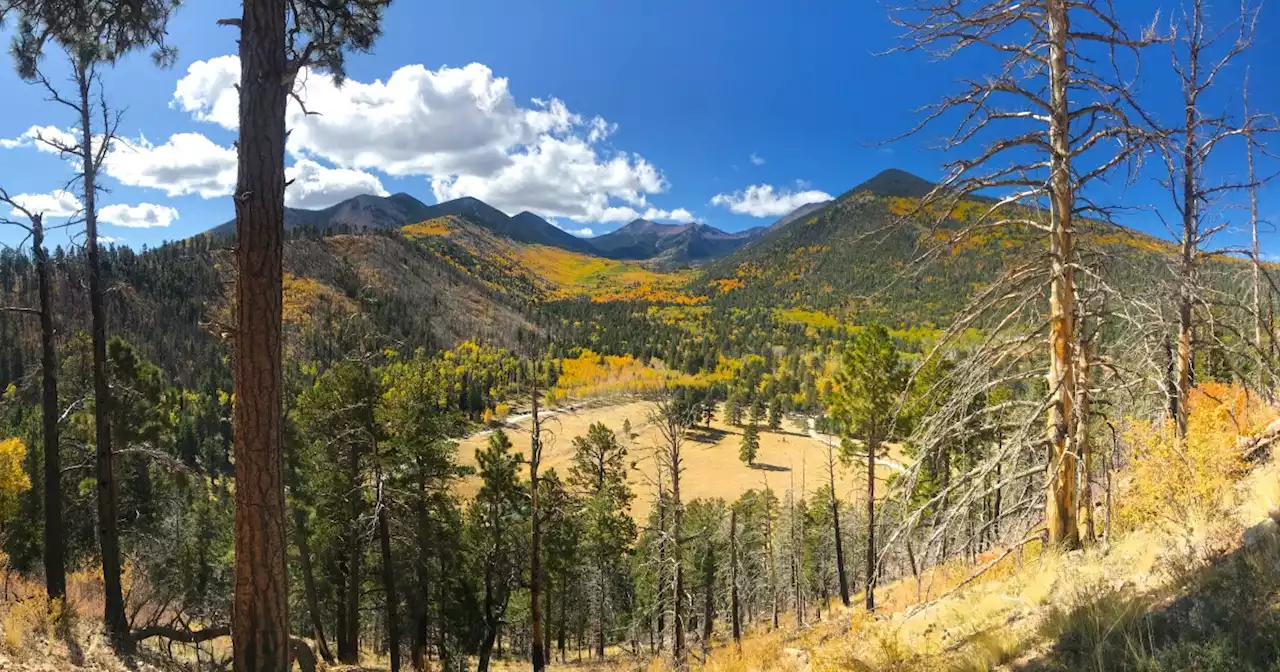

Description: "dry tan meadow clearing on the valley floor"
458 401 900 521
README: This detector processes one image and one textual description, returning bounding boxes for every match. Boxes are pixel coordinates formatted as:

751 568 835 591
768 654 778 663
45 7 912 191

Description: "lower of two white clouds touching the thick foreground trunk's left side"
104 133 236 198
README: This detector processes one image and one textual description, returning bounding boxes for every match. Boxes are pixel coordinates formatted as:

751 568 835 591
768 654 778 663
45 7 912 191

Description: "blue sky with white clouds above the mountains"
0 0 1280 253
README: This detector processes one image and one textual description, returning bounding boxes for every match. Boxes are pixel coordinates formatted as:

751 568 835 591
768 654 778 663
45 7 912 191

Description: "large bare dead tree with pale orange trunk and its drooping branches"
891 0 1155 548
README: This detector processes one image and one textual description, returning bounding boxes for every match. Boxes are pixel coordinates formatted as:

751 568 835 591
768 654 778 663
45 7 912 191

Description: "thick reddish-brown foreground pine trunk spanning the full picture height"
232 0 289 672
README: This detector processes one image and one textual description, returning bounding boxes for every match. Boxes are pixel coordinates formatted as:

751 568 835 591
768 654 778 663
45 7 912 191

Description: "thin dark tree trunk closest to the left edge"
31 215 67 599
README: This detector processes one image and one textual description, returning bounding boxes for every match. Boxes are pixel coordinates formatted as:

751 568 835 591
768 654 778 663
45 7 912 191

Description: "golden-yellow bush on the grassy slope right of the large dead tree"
1116 383 1275 531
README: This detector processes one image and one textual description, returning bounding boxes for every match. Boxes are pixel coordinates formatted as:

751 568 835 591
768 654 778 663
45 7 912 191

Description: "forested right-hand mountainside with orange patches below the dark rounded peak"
690 170 1213 326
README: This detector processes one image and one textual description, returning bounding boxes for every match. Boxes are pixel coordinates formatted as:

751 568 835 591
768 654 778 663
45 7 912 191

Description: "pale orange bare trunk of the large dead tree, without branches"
1044 0 1080 549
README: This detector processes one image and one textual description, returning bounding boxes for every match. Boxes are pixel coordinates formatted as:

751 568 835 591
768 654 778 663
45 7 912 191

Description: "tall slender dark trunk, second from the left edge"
76 60 134 653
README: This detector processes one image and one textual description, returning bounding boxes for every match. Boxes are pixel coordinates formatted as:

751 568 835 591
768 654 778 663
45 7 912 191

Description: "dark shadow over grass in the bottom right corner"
1014 524 1280 672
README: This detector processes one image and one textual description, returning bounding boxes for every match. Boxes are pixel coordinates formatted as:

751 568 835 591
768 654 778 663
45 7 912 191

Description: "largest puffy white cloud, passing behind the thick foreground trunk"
172 56 691 221
